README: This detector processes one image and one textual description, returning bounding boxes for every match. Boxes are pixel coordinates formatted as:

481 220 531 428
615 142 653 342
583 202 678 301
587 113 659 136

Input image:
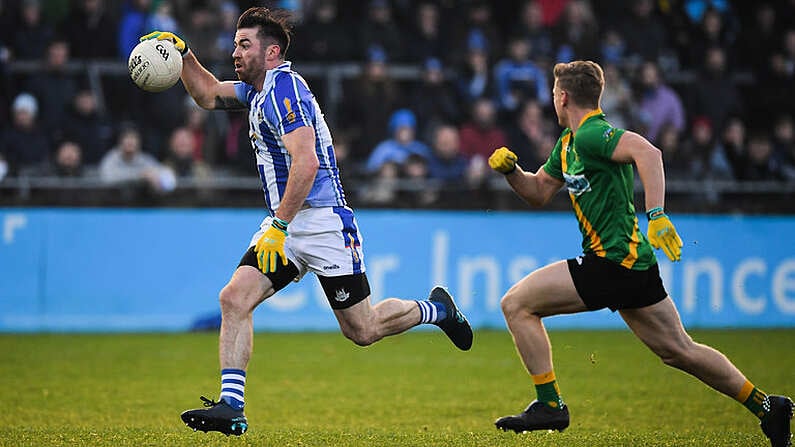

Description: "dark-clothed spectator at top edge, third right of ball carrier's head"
409 1 451 65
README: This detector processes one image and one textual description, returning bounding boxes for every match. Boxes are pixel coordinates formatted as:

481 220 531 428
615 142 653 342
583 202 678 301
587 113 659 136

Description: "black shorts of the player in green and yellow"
567 254 668 312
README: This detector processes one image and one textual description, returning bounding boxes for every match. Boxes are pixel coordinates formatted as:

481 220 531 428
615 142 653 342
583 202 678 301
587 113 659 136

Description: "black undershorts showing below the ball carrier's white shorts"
238 247 370 309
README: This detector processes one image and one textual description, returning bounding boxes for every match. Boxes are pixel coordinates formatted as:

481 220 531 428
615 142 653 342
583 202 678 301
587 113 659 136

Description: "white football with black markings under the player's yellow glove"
127 39 182 92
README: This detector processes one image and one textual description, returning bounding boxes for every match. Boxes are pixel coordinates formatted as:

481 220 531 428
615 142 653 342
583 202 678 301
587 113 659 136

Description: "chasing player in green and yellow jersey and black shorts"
489 61 793 447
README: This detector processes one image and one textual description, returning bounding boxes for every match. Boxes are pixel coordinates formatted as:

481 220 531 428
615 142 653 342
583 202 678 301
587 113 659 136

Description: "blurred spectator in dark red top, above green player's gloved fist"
460 98 508 160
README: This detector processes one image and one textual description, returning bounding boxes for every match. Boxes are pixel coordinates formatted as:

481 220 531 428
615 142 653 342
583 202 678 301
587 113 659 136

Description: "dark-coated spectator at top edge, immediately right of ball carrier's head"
290 0 359 62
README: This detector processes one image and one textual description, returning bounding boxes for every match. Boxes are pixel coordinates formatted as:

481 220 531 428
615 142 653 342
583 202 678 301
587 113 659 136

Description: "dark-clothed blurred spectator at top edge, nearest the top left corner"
11 0 55 60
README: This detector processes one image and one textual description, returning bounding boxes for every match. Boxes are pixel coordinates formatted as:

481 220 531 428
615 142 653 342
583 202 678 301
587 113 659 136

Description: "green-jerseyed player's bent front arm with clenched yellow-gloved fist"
489 147 563 207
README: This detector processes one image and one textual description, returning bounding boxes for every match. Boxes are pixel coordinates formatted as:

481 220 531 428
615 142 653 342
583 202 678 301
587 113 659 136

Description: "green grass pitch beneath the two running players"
0 330 795 447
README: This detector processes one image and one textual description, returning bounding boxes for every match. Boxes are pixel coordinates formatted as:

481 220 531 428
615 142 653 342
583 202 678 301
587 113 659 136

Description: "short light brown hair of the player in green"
552 61 605 109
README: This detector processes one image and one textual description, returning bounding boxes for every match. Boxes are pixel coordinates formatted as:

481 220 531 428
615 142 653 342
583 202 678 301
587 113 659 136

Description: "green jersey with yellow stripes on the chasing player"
544 109 657 270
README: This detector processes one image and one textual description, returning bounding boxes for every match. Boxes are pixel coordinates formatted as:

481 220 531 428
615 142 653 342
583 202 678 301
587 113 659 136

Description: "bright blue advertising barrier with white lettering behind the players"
0 208 795 332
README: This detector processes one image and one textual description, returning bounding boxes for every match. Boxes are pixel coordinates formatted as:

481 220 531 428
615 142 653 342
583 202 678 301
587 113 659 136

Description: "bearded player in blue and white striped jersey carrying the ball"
141 7 472 435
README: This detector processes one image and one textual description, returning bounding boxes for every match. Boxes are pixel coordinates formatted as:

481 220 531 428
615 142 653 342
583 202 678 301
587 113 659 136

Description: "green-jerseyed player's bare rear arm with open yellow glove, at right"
612 131 682 261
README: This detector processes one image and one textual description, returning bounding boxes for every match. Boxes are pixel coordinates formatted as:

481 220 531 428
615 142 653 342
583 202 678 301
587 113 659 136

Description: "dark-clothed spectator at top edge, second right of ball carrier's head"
360 0 404 61
